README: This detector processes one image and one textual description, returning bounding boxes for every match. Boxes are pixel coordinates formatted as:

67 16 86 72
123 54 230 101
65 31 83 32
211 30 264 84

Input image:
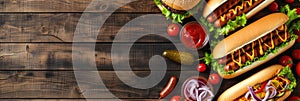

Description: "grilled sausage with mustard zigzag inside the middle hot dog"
218 25 290 71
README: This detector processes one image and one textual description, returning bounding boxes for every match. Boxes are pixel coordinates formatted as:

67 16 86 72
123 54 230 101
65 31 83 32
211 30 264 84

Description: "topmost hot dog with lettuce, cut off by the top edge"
203 0 274 35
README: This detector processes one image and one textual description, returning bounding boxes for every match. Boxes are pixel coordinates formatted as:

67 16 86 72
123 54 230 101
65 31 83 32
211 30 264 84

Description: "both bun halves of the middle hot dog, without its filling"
212 13 295 79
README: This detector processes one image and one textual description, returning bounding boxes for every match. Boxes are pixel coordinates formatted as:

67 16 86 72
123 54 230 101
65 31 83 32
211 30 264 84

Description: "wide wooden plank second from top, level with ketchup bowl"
0 13 175 42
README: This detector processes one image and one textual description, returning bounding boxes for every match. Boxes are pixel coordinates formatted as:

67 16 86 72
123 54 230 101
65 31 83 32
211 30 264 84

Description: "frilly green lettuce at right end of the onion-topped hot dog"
277 66 297 91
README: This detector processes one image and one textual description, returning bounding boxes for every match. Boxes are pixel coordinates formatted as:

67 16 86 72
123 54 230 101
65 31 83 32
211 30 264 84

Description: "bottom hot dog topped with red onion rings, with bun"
218 65 297 101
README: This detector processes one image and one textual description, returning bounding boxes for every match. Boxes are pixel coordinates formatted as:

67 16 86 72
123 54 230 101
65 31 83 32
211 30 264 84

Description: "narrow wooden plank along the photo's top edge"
0 0 159 12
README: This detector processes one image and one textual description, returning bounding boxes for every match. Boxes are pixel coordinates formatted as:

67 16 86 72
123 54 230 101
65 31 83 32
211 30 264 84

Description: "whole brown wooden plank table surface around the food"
0 0 300 101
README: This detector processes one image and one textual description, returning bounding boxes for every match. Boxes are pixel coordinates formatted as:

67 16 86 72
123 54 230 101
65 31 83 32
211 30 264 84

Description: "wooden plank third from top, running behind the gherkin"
0 43 203 70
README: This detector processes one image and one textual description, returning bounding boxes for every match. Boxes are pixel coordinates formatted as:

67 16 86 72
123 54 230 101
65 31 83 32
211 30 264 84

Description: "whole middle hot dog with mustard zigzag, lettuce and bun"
212 13 295 79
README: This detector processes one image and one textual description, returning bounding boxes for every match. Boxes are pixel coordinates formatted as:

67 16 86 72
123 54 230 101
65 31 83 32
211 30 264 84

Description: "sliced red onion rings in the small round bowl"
183 79 214 101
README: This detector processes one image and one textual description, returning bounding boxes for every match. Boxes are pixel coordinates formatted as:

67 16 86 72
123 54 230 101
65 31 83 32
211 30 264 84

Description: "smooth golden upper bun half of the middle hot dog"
213 13 289 58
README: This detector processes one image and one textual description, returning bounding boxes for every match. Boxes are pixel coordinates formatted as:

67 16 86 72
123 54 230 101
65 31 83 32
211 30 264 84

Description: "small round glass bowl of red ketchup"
180 21 209 49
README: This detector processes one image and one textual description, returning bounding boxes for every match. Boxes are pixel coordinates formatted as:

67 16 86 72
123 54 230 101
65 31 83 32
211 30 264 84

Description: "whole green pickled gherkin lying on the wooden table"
162 50 195 65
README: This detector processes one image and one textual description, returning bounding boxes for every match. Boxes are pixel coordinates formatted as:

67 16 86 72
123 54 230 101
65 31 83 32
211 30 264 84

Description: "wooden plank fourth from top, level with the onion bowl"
0 71 300 99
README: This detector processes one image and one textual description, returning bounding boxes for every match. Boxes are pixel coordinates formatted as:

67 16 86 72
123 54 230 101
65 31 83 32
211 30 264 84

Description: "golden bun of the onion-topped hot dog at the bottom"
218 65 291 101
